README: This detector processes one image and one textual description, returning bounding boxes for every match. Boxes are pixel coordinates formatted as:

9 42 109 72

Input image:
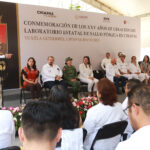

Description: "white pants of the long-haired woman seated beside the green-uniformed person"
80 78 98 92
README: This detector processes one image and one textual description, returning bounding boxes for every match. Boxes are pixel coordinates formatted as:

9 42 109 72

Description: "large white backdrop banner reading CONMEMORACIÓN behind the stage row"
18 4 140 70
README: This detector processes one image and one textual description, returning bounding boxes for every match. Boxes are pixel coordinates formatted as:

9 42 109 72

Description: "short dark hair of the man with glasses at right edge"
128 83 150 115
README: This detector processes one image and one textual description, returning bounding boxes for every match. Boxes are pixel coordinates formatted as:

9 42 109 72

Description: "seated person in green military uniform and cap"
63 57 80 98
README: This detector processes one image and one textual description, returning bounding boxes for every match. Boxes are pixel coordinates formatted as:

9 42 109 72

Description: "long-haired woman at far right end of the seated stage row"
140 55 150 74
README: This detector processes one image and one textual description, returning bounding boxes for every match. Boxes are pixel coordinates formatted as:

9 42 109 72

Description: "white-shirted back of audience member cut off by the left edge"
0 110 15 149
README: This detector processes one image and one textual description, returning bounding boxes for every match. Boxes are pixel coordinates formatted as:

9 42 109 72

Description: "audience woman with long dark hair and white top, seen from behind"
49 85 83 150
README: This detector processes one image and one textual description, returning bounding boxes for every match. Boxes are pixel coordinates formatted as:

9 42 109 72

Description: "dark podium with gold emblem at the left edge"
0 58 7 107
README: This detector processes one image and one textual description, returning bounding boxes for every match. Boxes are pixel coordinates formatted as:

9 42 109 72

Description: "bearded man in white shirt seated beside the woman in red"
41 56 66 89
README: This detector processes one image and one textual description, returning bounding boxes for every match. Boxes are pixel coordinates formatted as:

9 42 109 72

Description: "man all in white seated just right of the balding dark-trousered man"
118 53 137 79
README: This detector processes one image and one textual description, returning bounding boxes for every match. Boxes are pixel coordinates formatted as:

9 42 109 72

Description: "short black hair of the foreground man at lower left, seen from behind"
22 101 61 141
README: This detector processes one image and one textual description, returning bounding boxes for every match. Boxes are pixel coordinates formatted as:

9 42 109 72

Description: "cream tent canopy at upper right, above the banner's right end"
83 0 150 48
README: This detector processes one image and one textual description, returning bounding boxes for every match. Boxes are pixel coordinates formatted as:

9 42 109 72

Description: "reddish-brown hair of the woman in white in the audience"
97 78 118 106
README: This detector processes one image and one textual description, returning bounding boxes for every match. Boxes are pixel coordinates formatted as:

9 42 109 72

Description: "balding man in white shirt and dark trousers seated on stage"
106 58 127 94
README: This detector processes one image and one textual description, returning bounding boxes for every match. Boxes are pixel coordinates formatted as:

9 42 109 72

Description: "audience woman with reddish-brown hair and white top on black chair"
83 78 127 150
